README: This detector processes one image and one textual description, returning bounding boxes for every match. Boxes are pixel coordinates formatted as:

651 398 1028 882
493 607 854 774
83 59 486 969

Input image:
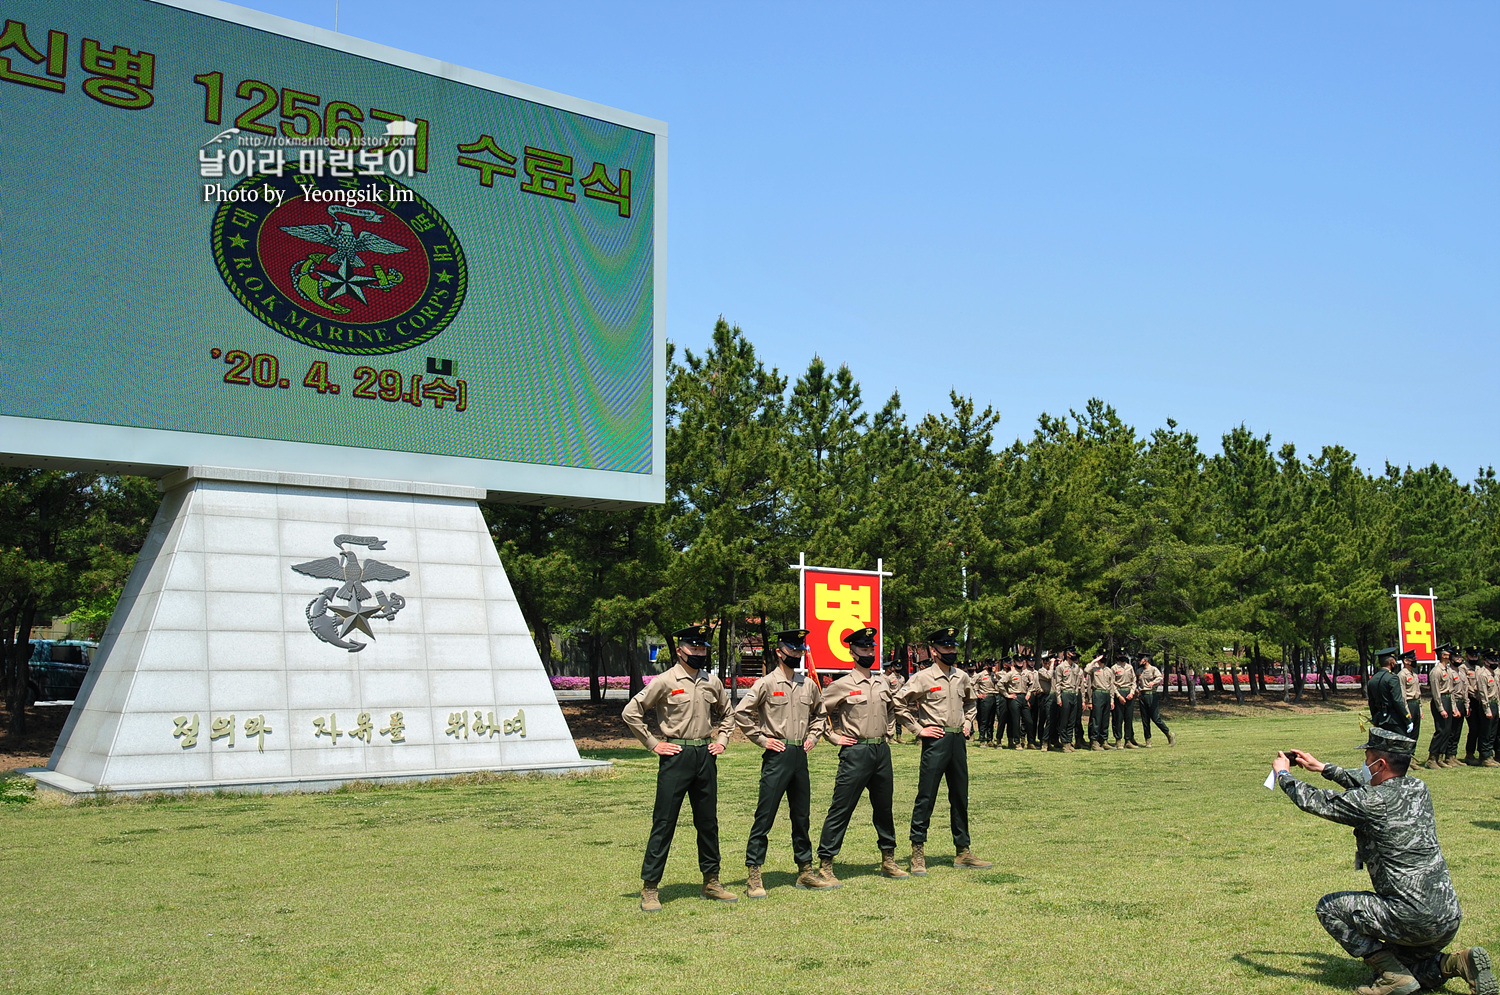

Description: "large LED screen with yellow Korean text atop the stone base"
0 0 665 500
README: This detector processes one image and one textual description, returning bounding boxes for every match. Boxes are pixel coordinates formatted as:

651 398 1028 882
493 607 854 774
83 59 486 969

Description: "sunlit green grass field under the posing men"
0 713 1500 995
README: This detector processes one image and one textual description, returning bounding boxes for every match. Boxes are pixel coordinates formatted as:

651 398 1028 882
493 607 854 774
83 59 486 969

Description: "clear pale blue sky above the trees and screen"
237 0 1500 479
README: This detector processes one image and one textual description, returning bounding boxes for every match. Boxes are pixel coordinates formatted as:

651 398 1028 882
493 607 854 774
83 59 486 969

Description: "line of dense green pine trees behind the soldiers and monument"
0 320 1500 729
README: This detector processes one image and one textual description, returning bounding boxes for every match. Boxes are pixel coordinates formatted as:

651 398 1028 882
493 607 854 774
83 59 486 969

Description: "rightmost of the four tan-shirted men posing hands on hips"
896 626 995 875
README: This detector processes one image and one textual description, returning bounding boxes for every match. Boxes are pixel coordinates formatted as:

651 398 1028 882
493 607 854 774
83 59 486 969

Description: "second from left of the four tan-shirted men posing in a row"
735 629 839 899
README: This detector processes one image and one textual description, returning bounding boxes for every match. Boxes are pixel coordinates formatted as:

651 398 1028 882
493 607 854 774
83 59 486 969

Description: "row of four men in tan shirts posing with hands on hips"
623 626 992 912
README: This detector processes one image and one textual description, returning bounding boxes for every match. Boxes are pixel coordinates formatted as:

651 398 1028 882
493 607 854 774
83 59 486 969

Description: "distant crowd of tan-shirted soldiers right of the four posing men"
975 647 1178 753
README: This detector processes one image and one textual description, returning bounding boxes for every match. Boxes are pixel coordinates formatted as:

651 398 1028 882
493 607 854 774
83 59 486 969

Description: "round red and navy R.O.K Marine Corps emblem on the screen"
213 167 468 356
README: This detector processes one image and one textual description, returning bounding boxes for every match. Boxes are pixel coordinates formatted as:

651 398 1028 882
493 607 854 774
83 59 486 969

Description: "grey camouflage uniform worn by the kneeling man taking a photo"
1278 764 1463 987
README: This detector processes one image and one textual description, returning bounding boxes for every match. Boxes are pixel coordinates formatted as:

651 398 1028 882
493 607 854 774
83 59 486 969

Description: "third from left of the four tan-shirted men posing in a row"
818 627 909 882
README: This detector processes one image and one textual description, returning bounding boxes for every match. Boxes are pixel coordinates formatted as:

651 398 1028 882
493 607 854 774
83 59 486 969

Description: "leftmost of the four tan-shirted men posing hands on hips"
621 626 740 912
